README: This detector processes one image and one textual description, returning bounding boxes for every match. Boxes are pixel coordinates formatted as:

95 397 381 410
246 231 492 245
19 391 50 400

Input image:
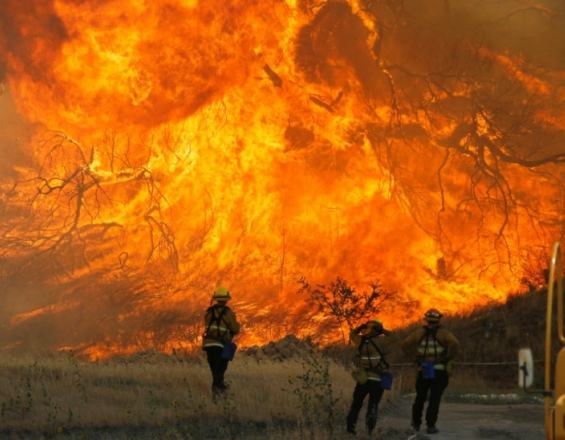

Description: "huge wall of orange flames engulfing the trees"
0 0 565 356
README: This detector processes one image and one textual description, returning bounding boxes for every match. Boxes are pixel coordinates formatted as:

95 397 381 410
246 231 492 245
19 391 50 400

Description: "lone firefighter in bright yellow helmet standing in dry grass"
202 287 240 396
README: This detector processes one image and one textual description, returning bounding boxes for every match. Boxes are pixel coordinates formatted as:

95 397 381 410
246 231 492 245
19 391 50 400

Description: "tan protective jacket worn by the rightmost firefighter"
402 326 459 371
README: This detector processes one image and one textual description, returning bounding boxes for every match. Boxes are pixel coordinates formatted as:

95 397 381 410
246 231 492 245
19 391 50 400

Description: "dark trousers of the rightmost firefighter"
412 370 449 426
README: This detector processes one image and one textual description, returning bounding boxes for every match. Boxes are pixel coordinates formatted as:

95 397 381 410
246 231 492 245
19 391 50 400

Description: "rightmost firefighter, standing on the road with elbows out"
402 309 459 434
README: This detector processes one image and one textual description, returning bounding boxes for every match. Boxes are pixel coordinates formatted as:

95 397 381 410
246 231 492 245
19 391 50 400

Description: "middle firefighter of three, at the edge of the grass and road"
347 320 389 435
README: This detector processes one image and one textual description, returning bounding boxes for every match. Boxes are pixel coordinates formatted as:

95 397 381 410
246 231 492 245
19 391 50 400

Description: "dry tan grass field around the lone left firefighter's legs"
0 353 392 439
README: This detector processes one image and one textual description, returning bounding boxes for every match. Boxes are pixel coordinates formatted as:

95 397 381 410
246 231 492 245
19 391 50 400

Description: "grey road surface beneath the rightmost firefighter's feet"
368 399 545 440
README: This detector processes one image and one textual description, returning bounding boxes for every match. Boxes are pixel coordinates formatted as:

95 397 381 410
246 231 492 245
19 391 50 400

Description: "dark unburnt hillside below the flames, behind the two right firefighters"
246 291 557 389
